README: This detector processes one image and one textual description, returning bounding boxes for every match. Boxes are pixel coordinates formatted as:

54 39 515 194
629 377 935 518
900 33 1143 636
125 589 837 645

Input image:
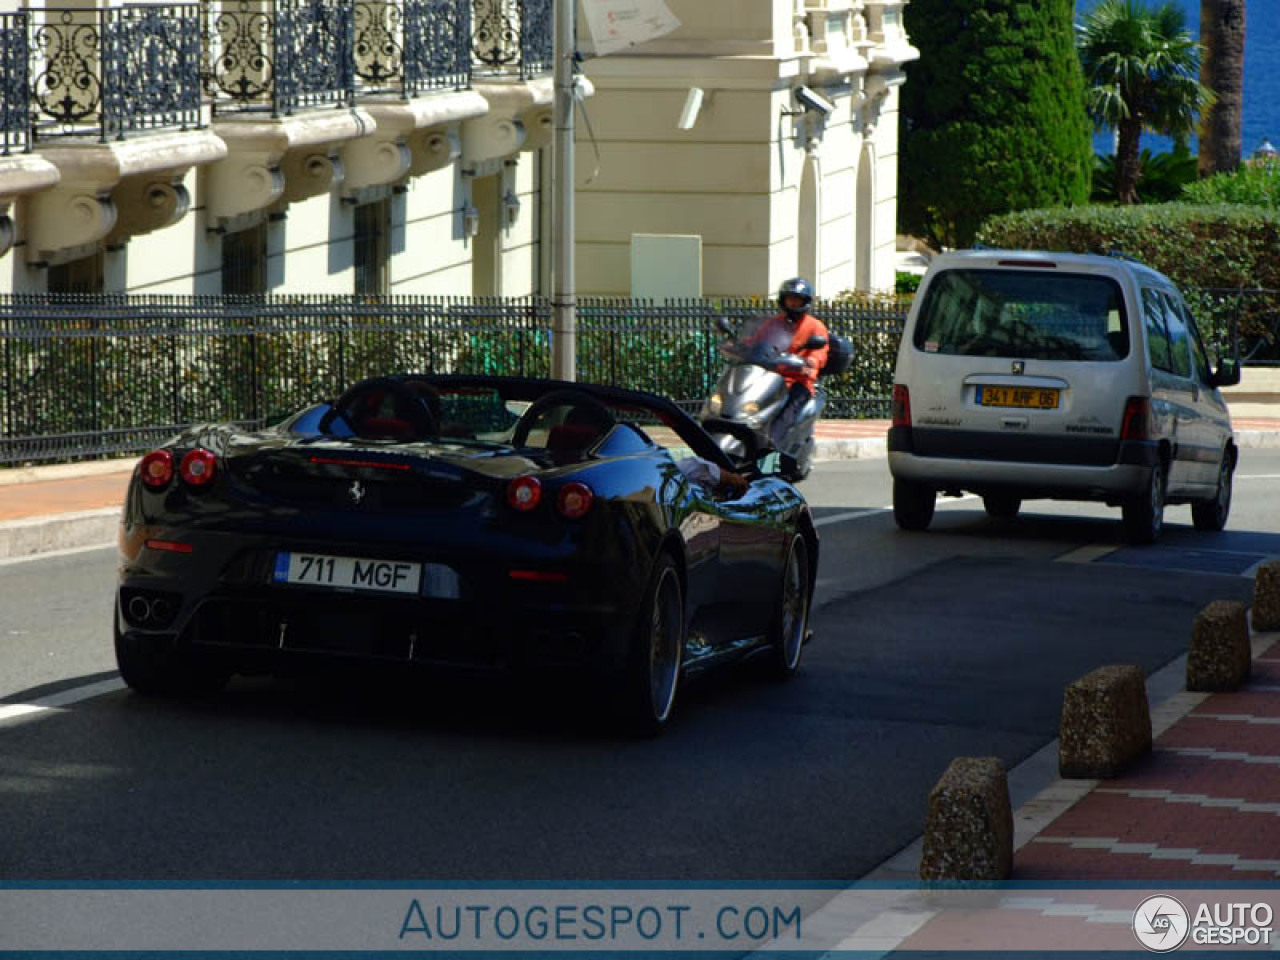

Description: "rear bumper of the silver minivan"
888 428 1160 500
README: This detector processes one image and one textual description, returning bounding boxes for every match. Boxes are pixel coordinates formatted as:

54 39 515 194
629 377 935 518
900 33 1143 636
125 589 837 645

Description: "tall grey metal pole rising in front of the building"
552 0 577 380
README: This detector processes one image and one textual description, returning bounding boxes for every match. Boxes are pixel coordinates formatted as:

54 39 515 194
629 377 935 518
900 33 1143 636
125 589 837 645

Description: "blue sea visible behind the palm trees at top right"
1075 0 1280 156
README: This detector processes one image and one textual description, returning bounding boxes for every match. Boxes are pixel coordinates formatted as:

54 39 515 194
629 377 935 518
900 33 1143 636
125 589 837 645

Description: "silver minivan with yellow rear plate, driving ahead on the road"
888 250 1240 543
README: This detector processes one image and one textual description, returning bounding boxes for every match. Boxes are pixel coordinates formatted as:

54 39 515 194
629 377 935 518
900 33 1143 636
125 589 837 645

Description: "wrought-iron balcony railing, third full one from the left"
356 0 471 99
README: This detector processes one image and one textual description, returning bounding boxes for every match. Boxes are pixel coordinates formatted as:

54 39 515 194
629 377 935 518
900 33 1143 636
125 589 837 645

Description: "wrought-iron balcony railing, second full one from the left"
205 0 356 116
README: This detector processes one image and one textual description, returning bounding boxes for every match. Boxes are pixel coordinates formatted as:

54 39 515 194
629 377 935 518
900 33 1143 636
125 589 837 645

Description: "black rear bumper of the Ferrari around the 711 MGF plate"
115 531 644 675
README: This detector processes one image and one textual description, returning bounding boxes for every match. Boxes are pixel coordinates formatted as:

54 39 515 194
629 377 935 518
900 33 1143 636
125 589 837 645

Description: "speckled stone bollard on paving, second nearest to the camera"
1057 666 1151 780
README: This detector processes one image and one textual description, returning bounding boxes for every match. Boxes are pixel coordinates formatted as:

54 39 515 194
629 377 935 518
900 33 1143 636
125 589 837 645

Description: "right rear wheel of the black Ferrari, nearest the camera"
621 553 685 737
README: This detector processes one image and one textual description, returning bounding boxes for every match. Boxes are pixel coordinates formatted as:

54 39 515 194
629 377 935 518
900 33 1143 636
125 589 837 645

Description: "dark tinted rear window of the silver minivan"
914 270 1129 362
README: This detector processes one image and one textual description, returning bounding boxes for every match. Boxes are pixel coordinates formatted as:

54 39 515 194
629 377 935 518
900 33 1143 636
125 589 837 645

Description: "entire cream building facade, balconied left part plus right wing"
0 0 915 297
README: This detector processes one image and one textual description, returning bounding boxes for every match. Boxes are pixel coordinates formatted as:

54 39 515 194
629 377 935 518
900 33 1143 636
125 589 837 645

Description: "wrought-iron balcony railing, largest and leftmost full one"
29 4 200 141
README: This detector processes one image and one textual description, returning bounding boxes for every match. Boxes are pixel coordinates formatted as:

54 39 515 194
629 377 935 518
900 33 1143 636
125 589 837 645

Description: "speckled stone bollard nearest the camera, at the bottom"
920 756 1014 881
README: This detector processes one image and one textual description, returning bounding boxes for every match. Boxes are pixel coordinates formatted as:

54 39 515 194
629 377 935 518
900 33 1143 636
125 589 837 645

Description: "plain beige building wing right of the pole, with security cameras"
577 0 918 296
